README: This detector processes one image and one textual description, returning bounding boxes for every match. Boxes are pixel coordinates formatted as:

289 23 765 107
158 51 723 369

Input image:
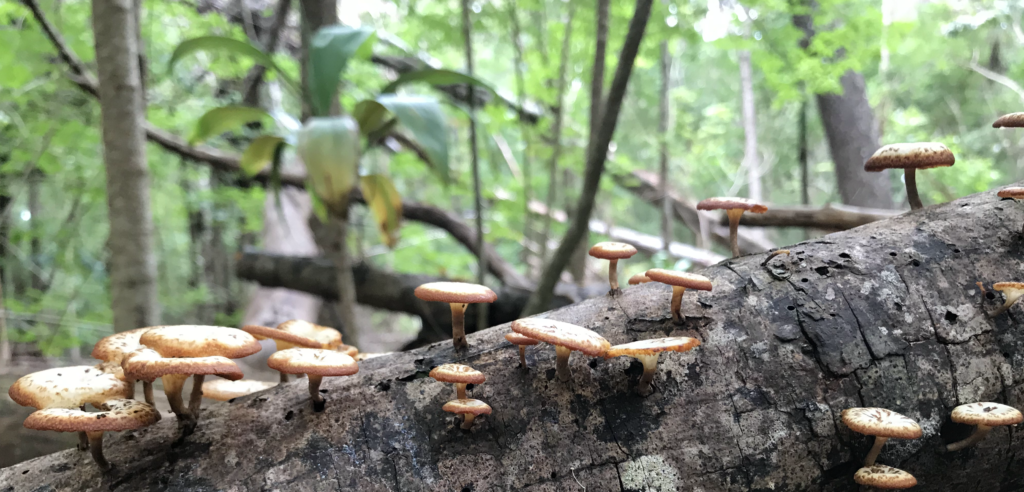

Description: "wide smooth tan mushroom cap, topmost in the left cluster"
139 325 262 359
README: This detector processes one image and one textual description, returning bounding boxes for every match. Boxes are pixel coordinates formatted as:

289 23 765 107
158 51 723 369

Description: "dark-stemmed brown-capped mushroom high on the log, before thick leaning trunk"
864 141 956 210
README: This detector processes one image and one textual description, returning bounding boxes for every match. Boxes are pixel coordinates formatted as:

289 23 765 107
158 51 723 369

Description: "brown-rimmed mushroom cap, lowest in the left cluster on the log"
25 399 160 433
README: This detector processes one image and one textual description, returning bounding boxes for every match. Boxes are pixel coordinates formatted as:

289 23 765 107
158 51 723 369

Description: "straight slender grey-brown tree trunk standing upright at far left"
92 0 160 331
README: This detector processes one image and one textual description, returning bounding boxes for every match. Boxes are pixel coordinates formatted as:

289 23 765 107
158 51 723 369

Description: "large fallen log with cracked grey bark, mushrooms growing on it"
8 186 1024 492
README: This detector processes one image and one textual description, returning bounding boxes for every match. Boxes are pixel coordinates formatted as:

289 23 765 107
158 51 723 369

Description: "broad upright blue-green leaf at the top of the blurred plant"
309 26 376 115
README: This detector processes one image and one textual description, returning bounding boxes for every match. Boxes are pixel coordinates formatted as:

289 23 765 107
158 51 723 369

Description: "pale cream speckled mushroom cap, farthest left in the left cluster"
7 366 132 409
